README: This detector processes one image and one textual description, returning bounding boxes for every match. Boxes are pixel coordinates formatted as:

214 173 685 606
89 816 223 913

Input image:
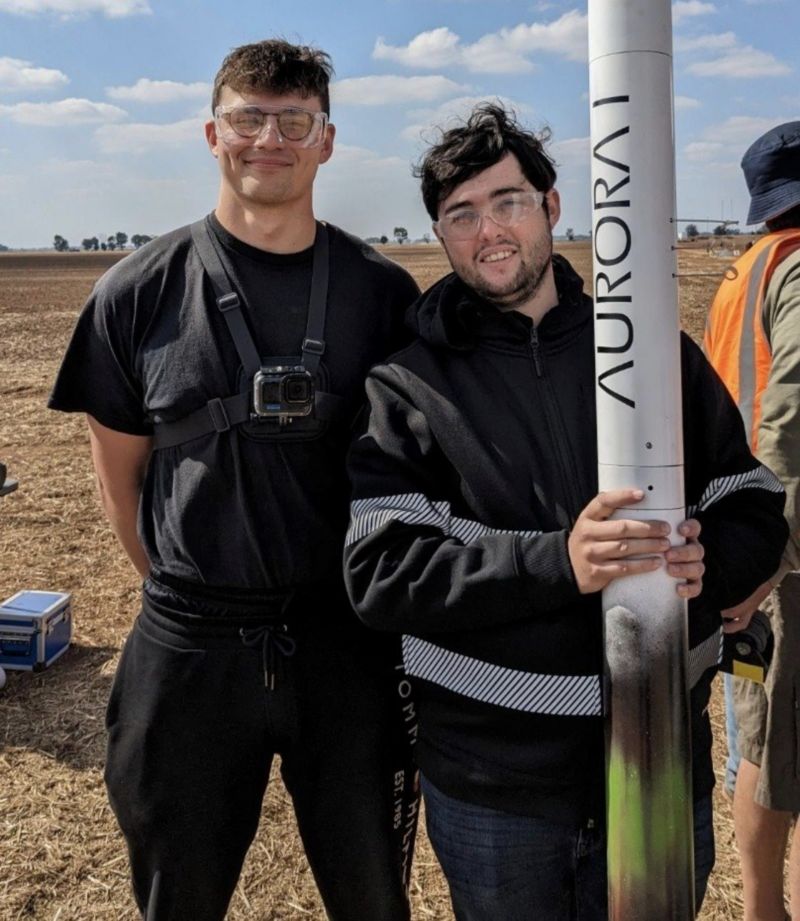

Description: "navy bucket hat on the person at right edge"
742 122 800 224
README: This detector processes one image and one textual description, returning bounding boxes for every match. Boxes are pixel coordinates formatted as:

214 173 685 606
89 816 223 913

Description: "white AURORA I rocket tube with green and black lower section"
589 0 694 921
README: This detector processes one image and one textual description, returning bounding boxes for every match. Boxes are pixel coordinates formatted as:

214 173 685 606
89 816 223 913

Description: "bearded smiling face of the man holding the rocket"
434 154 561 310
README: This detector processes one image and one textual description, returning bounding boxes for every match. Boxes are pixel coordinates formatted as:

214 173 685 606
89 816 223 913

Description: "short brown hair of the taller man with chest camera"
211 38 333 115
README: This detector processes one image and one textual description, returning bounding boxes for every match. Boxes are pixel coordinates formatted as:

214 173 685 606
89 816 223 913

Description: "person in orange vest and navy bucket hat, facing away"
704 121 800 921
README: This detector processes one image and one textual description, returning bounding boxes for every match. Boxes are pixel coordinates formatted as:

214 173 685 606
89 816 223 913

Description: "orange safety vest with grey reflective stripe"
703 229 800 453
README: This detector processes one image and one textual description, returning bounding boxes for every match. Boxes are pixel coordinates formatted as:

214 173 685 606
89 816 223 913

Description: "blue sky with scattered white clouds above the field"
0 0 800 247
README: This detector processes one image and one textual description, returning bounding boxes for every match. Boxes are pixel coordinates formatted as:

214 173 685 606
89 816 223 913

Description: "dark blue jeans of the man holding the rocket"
422 777 714 921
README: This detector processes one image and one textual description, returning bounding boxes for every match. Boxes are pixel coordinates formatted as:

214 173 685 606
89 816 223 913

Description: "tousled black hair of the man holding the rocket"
414 103 556 221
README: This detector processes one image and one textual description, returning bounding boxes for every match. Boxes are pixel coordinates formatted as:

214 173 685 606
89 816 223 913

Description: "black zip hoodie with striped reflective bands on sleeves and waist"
345 256 786 823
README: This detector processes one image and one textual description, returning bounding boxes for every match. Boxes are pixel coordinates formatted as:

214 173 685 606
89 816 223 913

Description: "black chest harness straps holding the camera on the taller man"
153 220 342 450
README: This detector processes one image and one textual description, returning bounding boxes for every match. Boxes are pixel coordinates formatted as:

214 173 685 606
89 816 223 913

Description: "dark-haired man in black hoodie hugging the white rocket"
345 105 786 921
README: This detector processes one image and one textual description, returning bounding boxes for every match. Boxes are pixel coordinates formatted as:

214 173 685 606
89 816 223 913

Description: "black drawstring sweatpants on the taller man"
105 585 417 921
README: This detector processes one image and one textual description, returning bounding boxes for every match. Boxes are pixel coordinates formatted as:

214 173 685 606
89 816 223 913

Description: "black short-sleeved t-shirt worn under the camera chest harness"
49 215 418 593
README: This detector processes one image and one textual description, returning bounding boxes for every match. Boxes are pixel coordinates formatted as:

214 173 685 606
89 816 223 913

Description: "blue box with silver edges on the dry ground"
0 589 72 671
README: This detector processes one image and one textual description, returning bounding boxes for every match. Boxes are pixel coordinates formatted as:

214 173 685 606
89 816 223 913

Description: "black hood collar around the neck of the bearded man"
406 254 591 350
